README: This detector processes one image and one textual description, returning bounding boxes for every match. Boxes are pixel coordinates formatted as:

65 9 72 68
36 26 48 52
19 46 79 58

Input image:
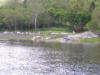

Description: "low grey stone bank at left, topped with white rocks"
0 32 33 40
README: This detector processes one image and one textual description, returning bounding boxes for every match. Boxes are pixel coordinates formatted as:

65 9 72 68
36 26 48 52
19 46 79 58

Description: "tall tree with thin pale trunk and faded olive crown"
27 0 44 32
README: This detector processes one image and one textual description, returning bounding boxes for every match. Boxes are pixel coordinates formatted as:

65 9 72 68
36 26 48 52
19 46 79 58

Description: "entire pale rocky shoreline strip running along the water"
0 31 99 43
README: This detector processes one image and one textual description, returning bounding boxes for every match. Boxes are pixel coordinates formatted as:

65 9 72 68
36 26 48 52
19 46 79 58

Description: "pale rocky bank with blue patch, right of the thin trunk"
32 31 99 43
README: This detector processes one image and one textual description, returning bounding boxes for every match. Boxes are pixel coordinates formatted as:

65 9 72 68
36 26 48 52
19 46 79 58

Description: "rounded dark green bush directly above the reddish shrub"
68 11 91 26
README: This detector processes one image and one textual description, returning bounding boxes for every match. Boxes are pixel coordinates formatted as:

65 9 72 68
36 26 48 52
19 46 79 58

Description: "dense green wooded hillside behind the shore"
0 0 100 32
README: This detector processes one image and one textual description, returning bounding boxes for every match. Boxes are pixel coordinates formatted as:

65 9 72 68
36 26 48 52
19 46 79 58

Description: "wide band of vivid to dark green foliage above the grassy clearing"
49 8 91 26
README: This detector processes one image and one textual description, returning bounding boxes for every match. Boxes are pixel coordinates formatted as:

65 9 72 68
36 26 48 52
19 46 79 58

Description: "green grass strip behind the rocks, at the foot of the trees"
0 24 73 34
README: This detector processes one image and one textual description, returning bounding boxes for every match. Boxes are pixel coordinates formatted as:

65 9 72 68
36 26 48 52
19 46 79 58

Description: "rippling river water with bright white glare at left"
0 41 100 75
